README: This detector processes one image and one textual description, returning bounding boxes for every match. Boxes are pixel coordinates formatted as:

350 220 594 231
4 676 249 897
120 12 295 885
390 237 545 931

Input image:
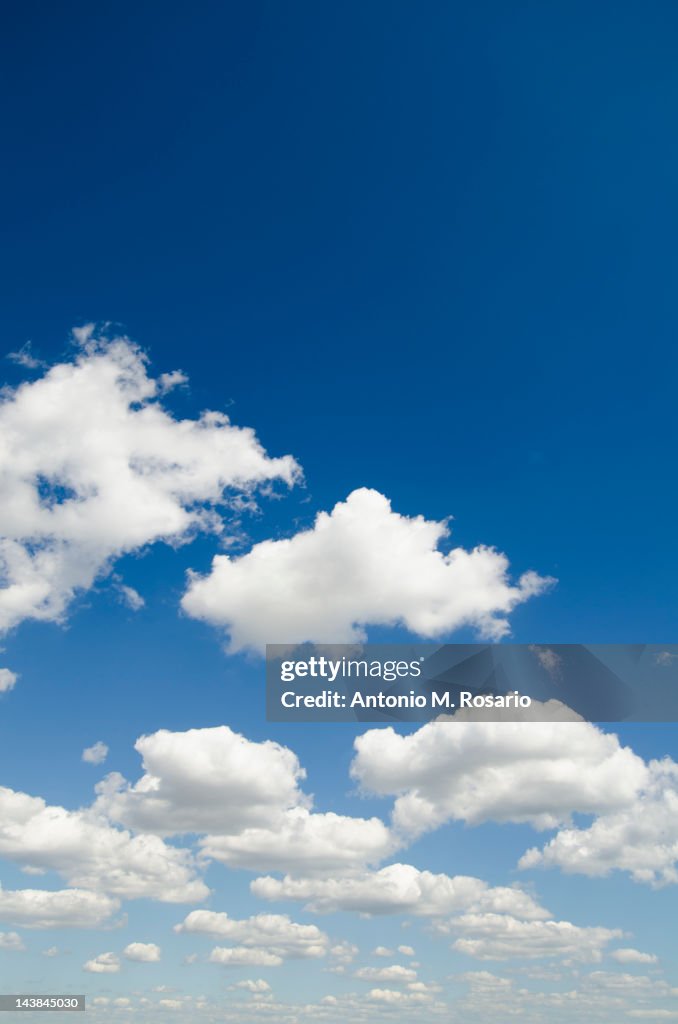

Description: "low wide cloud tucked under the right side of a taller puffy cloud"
201 807 393 873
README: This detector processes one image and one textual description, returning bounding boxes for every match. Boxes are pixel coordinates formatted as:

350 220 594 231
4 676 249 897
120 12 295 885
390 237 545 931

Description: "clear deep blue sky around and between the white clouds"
0 0 678 1003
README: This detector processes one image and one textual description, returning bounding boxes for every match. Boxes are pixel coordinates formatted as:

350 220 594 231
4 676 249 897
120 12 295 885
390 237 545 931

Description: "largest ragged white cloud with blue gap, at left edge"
0 328 298 630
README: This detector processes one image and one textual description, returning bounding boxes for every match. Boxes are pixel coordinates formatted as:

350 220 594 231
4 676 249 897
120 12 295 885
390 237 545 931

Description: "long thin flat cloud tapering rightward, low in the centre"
250 864 548 920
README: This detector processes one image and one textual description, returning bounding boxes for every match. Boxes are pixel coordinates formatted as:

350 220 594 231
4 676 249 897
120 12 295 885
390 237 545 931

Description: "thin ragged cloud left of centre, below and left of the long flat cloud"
174 910 329 958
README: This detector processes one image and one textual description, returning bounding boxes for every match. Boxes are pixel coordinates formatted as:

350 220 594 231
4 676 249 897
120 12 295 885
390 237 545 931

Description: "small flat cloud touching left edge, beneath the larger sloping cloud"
0 888 120 928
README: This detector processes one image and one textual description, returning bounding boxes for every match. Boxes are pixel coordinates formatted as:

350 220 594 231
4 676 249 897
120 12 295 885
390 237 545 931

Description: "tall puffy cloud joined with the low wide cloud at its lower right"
95 726 393 872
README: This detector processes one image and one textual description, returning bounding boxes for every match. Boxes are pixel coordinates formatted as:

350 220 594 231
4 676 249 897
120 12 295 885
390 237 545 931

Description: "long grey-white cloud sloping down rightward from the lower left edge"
0 786 209 902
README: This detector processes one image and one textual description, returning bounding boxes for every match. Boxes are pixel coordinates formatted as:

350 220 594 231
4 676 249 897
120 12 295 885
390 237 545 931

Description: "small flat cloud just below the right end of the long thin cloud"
447 913 623 963
